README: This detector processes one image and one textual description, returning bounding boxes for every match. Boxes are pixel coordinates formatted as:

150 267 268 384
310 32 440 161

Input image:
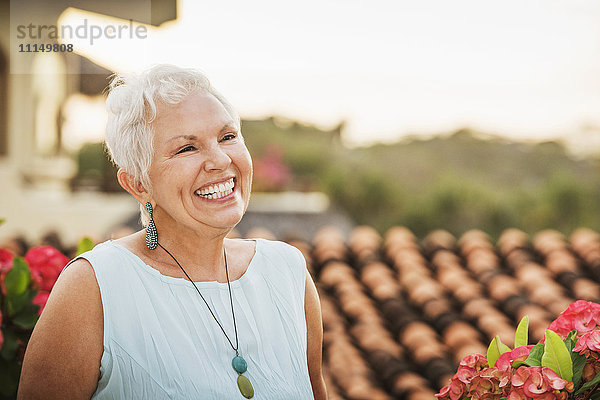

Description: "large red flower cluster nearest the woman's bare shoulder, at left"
25 246 69 292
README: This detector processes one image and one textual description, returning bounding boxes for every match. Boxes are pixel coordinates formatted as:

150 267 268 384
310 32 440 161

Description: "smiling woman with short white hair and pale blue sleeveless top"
19 65 327 400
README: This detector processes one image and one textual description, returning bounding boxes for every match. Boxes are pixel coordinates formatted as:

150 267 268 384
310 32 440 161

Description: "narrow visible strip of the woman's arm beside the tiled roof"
304 273 327 400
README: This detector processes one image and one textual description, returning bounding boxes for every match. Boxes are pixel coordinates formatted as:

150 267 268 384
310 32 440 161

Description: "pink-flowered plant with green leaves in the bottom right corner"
436 300 600 400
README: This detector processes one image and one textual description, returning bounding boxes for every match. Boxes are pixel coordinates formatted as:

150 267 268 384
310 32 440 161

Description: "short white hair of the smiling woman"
106 64 240 226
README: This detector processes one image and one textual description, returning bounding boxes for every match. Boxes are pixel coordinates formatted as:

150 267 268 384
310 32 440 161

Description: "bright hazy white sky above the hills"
62 0 600 148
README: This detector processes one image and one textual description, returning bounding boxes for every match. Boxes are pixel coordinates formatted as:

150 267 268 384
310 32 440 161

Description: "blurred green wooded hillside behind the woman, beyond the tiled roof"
89 118 600 238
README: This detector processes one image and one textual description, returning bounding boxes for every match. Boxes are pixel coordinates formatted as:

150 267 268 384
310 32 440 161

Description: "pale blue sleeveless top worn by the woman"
69 239 313 400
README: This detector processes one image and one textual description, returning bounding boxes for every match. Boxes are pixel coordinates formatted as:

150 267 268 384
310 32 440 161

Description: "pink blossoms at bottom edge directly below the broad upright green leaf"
511 366 567 399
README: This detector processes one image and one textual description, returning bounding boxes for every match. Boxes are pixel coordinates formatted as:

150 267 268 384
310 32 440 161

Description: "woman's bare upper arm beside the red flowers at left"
17 259 104 400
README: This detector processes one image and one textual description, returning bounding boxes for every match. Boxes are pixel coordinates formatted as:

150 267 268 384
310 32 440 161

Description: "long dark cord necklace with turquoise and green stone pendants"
158 243 254 399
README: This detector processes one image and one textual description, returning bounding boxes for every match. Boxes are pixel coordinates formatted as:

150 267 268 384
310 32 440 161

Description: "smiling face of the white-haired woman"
150 90 252 234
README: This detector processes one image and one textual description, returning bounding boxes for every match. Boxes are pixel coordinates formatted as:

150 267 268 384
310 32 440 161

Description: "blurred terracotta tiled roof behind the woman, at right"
278 227 600 400
